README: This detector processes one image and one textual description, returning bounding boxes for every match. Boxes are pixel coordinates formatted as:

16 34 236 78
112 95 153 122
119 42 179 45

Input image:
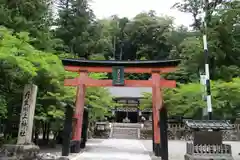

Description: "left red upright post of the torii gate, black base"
72 72 87 153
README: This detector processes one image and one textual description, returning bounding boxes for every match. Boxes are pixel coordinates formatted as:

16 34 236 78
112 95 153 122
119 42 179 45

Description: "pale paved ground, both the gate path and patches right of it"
73 139 240 160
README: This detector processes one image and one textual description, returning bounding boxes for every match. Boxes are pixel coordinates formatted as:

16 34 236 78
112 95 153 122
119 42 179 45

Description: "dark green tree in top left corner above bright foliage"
0 0 58 51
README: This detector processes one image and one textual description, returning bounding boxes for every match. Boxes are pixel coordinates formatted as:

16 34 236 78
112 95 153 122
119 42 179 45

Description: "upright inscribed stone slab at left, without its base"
17 84 37 144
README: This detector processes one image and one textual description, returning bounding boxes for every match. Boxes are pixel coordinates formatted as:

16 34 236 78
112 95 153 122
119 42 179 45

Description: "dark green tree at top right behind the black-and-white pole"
172 0 240 80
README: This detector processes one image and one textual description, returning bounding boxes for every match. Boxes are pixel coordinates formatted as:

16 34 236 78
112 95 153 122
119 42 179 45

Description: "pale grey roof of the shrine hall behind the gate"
106 87 152 99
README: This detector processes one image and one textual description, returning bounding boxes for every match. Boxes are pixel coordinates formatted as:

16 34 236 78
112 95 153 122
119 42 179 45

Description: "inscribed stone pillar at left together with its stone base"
3 84 39 160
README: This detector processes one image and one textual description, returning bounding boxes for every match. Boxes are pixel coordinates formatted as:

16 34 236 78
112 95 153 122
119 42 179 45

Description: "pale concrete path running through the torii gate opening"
76 139 151 160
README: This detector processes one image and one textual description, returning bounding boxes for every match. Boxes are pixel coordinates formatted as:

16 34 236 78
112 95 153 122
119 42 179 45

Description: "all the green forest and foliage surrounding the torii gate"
0 0 240 144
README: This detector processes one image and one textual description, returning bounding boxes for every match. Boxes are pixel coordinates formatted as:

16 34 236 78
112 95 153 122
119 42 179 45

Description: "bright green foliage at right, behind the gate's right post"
141 78 240 119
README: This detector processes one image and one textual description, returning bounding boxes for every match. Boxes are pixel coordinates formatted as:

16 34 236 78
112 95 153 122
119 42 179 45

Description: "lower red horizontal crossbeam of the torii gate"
64 77 176 88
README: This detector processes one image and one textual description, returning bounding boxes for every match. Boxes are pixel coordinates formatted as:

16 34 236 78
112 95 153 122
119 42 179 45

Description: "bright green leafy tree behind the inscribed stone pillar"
0 27 64 138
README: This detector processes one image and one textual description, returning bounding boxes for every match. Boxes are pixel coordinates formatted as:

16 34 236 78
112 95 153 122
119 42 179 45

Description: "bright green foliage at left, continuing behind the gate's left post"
0 27 113 135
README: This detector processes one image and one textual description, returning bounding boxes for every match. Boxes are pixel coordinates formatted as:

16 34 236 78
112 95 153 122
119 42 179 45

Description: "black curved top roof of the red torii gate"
62 59 180 67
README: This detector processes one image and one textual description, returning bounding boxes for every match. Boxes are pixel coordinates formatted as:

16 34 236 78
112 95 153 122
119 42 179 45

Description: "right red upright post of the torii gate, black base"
152 72 162 157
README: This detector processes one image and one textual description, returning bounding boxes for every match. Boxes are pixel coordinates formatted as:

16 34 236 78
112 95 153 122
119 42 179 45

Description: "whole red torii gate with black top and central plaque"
62 59 180 159
